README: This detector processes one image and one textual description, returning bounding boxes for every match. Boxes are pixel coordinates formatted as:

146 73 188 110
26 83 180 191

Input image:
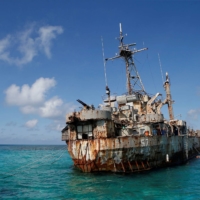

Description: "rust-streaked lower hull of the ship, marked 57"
67 135 200 172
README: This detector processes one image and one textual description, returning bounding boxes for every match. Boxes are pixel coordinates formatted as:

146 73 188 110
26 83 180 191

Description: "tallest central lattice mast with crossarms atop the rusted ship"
106 23 148 95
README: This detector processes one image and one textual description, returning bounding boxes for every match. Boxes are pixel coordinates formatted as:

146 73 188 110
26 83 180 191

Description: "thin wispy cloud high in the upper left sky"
0 26 63 66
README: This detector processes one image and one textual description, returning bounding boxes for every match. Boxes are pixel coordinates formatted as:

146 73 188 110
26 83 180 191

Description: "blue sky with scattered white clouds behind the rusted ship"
0 0 200 144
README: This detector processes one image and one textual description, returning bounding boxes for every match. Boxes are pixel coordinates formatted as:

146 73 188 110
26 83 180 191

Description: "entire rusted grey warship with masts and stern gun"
62 24 200 172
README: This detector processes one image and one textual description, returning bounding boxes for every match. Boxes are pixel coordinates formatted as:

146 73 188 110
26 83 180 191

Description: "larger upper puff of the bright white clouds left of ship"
5 77 56 106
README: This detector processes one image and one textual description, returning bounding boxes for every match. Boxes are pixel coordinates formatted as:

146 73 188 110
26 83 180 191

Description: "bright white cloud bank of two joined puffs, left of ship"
5 77 76 119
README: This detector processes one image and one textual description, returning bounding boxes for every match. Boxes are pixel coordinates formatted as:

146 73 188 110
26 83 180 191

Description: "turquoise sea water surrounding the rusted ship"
0 145 200 200
